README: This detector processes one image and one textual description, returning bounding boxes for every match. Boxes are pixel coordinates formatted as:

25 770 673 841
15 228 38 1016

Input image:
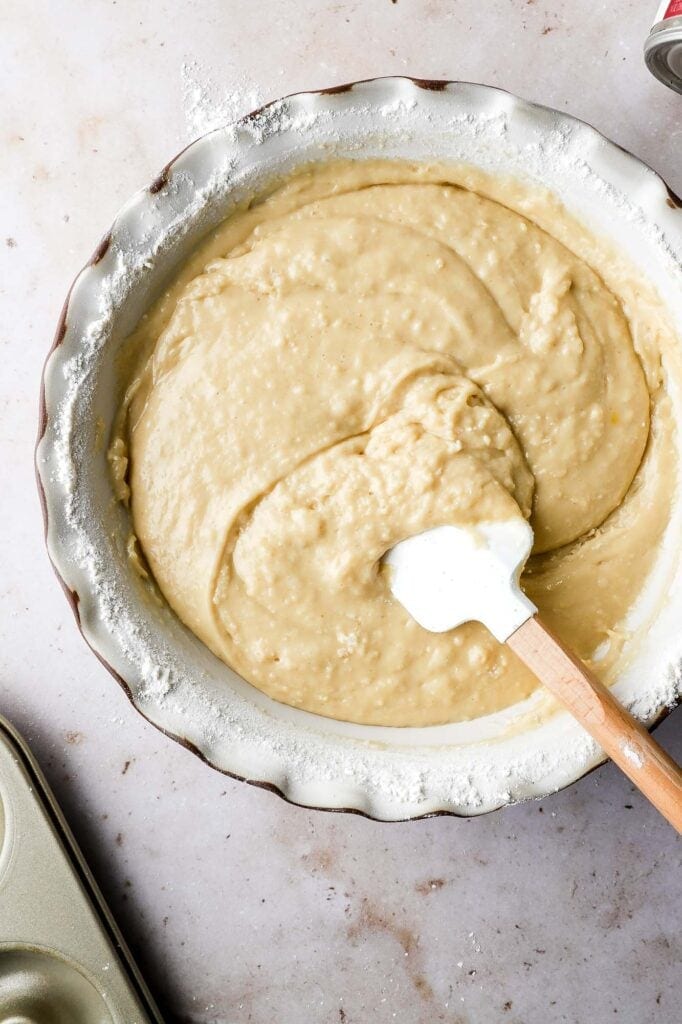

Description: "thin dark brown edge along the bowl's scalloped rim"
34 76 682 824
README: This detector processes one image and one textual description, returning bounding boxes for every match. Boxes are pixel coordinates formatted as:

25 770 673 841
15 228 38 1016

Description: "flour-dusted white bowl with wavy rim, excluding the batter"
37 78 682 819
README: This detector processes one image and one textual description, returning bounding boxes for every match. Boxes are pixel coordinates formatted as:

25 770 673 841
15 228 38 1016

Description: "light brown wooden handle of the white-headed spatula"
507 616 682 833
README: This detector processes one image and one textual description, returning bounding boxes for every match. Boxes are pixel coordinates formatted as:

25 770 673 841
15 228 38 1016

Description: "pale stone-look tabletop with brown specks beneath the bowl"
0 0 682 1024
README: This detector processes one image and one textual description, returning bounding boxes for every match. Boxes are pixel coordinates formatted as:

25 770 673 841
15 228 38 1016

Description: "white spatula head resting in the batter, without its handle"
384 516 538 643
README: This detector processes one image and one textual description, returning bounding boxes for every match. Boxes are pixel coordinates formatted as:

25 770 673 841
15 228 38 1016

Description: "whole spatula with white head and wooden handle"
384 517 682 833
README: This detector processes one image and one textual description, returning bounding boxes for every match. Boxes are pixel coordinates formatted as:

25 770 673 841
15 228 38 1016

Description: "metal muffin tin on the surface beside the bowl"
0 717 162 1024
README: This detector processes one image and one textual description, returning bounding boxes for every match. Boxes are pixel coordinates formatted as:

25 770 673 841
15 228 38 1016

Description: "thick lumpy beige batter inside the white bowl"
111 163 667 725
